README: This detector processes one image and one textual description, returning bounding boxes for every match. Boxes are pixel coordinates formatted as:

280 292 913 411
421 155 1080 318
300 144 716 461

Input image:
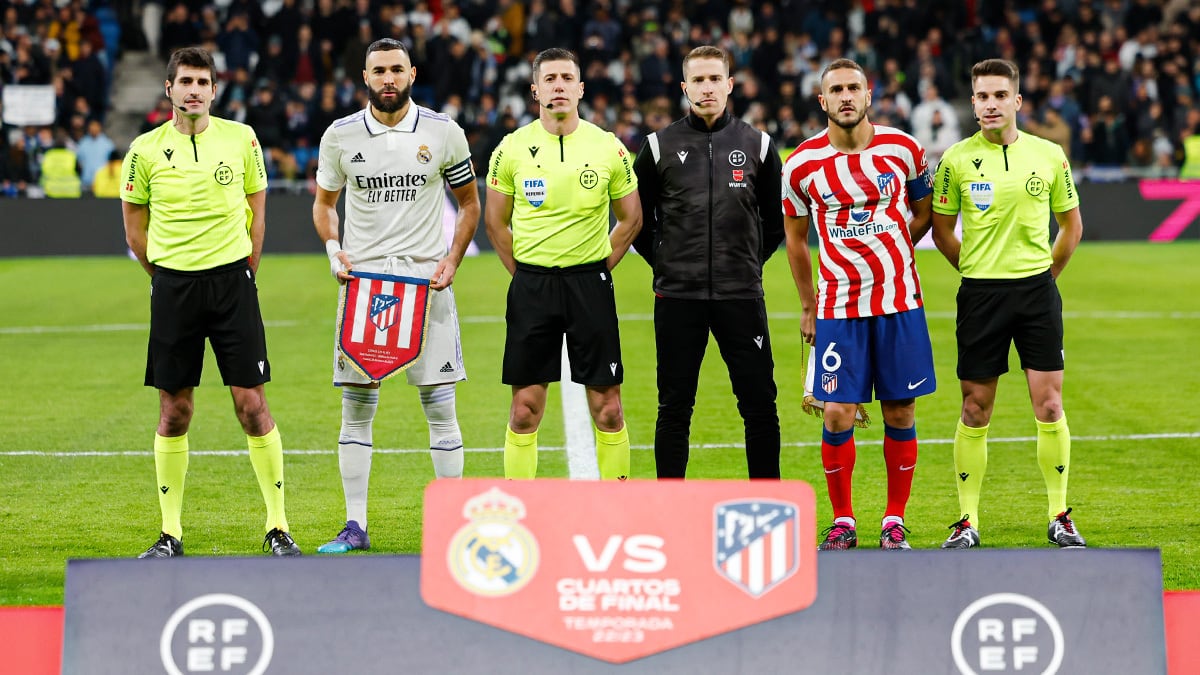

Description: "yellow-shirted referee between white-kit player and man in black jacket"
485 48 642 479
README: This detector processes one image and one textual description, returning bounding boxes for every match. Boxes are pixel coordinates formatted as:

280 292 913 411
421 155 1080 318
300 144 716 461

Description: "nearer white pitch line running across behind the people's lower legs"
0 431 1200 456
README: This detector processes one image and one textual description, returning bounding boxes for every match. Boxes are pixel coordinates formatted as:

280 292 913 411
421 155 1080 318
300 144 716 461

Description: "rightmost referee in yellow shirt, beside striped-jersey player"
934 59 1085 549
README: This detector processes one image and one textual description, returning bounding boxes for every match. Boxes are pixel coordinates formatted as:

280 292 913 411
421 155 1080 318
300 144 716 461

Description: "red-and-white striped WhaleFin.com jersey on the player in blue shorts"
782 125 934 318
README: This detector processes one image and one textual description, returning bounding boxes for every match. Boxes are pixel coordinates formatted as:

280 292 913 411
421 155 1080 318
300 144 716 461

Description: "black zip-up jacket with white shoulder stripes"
634 110 784 300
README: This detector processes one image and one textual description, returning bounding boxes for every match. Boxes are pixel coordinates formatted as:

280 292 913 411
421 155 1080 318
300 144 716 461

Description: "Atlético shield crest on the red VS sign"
713 500 800 597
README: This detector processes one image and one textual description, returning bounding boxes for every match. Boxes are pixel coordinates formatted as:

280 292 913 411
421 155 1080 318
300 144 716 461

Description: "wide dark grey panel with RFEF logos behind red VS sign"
62 549 1166 675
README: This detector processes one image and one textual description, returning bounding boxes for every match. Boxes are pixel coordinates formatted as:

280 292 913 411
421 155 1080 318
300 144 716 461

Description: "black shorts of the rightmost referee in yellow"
955 270 1063 380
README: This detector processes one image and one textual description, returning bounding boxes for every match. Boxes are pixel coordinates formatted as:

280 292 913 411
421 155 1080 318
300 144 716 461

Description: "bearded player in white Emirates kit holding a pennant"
312 38 480 554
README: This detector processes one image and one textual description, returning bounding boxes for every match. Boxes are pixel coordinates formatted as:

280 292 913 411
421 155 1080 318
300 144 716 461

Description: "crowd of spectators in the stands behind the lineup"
0 0 1200 196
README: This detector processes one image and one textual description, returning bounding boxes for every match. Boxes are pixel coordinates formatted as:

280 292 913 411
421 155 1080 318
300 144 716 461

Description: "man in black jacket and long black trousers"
634 46 784 478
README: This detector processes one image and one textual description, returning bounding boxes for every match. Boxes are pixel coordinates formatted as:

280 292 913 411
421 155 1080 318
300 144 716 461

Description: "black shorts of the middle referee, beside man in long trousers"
503 261 625 387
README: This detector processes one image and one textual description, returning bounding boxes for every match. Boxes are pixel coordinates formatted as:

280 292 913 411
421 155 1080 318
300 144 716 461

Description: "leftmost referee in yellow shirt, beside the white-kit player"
121 48 300 558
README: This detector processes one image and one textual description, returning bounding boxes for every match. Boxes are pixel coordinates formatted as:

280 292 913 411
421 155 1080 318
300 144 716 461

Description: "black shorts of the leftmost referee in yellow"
145 261 271 393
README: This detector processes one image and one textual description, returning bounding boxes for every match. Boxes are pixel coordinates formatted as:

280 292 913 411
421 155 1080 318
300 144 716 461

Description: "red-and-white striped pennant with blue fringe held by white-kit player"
337 271 431 382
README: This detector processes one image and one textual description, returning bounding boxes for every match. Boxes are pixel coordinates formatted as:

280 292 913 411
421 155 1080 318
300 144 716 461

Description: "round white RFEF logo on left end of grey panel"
158 593 275 675
